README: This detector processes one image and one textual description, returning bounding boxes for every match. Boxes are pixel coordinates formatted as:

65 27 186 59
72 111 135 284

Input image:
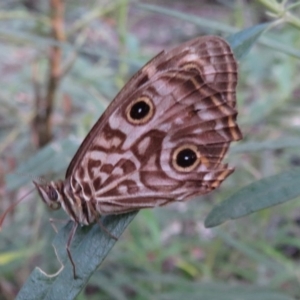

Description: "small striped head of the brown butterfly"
33 181 63 210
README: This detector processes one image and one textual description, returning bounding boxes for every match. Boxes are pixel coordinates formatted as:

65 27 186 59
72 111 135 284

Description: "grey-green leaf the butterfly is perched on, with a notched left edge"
16 212 137 300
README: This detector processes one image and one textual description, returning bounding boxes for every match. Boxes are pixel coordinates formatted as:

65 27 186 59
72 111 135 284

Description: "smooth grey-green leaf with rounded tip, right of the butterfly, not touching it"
205 168 300 227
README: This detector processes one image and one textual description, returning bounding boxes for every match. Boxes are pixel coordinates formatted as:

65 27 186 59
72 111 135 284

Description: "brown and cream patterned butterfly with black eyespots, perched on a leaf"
35 36 242 275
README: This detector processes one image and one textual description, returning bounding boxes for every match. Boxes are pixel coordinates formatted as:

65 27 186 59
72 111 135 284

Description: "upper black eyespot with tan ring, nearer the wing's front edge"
126 96 154 125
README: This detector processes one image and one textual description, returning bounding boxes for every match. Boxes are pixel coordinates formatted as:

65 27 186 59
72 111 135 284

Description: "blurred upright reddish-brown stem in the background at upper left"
34 0 65 147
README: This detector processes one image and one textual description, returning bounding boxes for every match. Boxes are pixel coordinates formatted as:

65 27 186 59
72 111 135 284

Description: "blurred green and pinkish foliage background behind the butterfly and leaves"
0 0 300 300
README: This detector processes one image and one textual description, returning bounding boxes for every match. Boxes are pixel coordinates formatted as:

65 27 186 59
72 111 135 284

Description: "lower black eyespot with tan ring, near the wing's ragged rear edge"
173 145 200 172
